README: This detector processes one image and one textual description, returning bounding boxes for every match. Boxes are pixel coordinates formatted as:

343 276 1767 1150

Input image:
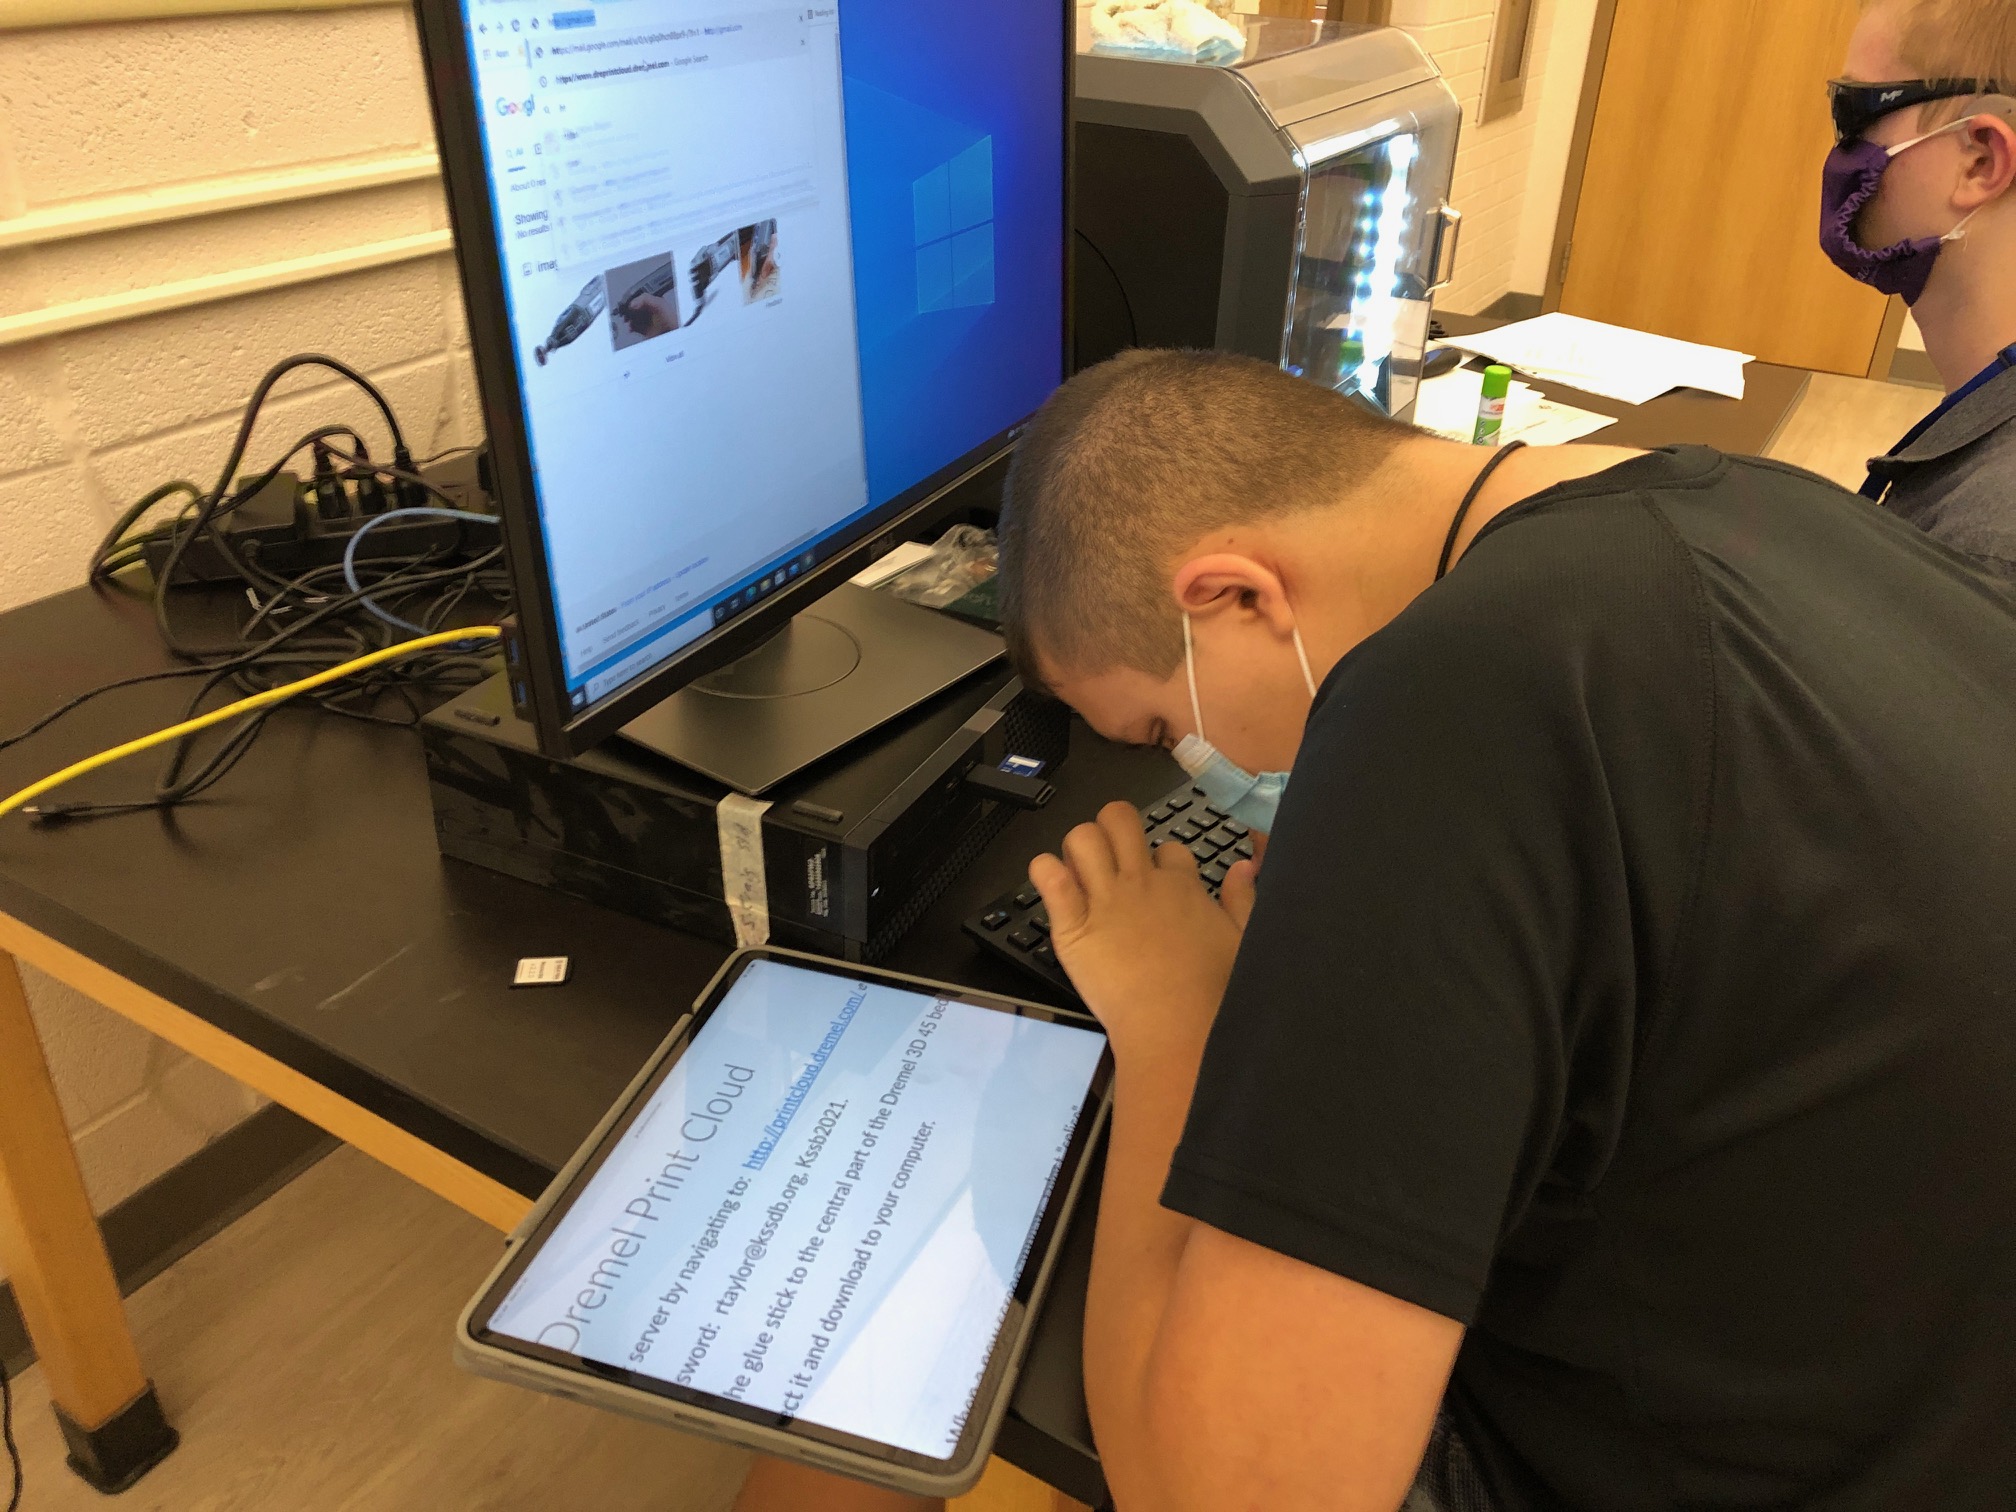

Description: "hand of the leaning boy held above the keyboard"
1028 802 1254 1058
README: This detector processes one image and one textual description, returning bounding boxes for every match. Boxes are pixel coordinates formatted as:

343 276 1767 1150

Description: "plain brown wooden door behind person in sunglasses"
1556 0 1903 377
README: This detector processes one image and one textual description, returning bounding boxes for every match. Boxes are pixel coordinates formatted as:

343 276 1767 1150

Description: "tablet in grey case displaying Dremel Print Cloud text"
456 950 1113 1496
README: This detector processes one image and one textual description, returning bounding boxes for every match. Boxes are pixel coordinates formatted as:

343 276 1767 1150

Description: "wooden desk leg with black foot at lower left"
0 952 177 1492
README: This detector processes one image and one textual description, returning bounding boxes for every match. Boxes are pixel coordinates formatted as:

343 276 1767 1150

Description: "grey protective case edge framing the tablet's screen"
456 948 1113 1498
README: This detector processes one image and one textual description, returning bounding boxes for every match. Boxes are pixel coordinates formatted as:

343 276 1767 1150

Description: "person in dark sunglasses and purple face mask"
1820 0 2016 579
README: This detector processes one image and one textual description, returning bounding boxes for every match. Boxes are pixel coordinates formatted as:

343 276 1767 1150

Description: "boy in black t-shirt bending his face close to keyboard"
1002 353 2016 1512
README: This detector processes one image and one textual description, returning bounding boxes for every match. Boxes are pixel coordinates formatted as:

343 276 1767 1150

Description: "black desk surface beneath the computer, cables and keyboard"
0 354 1806 1502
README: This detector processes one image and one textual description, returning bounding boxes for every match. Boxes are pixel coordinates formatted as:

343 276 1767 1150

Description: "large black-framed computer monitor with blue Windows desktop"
419 0 1073 788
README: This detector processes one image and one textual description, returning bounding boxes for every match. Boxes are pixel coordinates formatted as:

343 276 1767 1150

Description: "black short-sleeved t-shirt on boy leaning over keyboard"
1163 448 2016 1512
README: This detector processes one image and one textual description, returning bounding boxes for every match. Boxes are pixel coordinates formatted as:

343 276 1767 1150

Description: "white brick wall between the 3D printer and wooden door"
1393 0 1593 314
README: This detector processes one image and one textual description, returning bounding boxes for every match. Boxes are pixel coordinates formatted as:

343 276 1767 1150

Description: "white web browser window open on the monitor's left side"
472 0 869 702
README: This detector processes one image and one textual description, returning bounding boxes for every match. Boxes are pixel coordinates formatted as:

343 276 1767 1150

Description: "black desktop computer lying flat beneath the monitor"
419 665 1070 962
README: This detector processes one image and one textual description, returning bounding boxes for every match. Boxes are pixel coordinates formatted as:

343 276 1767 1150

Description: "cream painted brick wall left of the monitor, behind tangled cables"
0 6 480 1257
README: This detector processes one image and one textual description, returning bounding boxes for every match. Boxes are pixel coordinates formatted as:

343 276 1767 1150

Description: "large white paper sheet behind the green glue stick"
1445 310 1756 405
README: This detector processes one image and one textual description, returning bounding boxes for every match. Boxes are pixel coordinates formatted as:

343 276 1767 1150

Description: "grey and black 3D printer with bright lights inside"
1073 12 1462 417
